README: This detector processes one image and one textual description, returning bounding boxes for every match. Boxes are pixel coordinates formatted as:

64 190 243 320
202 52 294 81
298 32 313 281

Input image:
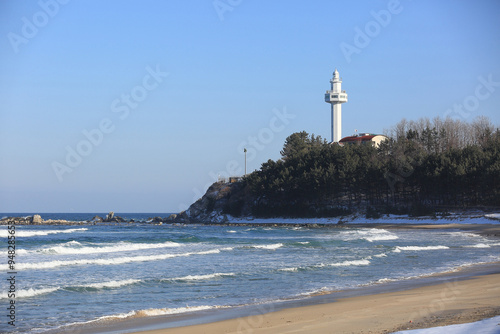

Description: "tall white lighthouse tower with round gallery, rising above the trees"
325 69 347 143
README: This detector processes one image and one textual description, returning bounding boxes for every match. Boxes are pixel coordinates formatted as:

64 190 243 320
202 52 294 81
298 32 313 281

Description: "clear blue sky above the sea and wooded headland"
0 0 500 212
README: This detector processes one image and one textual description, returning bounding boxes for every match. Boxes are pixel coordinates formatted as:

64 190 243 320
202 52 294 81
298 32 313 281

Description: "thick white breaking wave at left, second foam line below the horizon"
28 241 181 255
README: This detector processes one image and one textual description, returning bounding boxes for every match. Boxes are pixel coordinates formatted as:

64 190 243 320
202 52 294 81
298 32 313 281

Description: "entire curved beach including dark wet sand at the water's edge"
56 223 500 334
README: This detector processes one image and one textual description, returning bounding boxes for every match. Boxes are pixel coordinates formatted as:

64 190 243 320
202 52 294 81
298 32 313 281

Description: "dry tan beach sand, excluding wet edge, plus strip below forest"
127 224 500 334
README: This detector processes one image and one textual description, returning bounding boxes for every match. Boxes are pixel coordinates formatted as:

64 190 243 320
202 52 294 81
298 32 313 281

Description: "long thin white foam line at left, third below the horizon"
11 247 232 270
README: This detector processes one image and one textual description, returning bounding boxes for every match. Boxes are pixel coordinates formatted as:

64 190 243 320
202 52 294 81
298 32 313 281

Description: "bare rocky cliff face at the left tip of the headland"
174 182 252 223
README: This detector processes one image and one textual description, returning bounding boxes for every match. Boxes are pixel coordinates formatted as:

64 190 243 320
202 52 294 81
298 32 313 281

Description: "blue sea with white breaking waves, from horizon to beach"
0 213 500 333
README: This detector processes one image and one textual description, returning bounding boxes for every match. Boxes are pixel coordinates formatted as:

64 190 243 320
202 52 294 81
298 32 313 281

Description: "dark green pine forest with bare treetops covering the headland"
184 117 500 218
